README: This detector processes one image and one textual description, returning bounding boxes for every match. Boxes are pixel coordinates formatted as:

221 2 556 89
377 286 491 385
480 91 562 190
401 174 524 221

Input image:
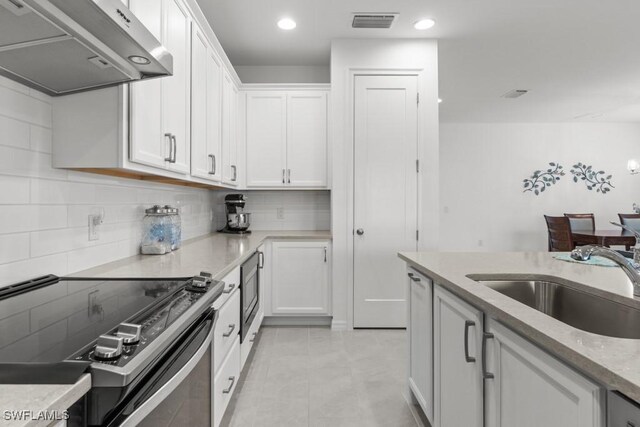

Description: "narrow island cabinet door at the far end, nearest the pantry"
407 268 433 423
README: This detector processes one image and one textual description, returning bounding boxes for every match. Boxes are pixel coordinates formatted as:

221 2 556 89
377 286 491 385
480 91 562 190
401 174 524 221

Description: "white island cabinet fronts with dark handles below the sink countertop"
407 268 611 427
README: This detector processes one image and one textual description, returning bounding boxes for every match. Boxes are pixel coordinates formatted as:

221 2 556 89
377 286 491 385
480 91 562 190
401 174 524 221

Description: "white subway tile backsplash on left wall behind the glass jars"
0 78 213 285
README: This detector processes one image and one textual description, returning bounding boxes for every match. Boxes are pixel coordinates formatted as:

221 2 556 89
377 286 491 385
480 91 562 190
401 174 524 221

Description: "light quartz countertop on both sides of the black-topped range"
0 231 331 427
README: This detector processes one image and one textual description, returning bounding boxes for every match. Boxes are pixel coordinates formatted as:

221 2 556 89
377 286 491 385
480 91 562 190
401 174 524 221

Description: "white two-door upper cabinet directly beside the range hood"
129 0 191 174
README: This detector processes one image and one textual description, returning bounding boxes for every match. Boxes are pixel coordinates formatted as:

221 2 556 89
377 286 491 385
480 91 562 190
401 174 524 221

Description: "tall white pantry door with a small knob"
353 76 418 328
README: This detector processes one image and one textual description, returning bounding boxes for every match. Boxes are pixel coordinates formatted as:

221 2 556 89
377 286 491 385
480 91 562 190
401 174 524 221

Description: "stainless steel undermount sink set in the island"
474 279 640 339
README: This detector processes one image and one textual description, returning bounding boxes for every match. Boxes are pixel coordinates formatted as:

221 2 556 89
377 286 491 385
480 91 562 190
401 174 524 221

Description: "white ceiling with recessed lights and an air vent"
198 0 640 122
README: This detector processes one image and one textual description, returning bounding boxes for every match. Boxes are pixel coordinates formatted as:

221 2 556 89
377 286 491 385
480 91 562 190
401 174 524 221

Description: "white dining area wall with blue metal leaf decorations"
440 123 640 251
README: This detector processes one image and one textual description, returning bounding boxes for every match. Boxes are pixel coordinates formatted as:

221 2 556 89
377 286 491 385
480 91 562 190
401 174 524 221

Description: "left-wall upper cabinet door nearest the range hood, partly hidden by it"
129 0 165 169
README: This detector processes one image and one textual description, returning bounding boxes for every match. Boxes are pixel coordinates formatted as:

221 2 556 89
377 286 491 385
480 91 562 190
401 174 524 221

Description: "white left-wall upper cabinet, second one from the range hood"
191 24 223 181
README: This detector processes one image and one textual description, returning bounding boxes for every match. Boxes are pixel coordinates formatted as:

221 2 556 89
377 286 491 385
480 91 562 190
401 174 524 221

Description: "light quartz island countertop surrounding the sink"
399 252 640 402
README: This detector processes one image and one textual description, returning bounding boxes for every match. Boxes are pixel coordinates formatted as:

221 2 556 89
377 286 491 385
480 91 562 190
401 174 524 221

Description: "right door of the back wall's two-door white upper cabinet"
287 91 327 188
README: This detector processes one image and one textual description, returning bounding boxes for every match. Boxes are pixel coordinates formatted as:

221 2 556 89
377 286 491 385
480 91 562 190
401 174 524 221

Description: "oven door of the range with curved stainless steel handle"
106 308 217 427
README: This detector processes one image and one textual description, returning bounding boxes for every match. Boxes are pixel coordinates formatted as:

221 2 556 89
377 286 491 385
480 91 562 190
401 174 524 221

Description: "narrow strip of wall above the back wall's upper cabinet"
234 65 330 83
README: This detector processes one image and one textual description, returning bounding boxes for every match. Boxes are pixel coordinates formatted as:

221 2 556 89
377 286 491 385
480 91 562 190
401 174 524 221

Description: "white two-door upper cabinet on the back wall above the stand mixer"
246 91 327 188
